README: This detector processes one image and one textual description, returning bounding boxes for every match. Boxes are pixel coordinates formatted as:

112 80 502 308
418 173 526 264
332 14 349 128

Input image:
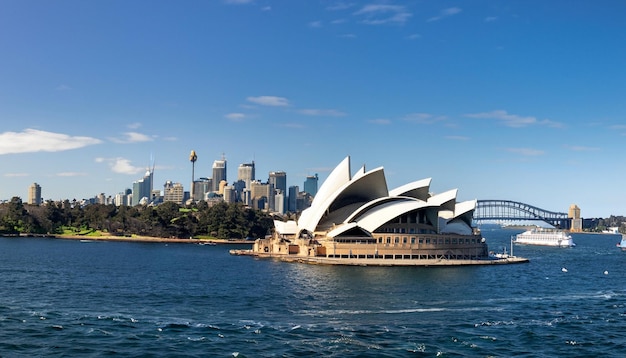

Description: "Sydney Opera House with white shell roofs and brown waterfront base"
233 156 521 265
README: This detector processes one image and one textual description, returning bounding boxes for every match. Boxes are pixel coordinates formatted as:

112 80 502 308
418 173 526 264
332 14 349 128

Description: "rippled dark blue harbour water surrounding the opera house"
0 229 626 357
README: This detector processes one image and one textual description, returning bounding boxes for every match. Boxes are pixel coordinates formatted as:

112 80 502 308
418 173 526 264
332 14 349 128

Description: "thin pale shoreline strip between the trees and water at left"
6 234 254 245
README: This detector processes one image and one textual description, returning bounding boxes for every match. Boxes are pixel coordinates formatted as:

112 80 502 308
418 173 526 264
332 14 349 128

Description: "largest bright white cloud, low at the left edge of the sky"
0 129 102 155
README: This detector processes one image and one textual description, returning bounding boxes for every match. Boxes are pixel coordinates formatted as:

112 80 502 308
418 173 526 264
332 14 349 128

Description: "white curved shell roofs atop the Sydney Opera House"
288 156 476 237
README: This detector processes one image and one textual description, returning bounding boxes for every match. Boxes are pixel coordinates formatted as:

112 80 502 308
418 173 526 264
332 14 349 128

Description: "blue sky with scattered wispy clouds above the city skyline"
0 0 626 217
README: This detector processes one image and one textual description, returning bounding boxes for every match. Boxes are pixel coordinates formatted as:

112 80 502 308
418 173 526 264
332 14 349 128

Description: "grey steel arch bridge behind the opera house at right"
474 200 571 230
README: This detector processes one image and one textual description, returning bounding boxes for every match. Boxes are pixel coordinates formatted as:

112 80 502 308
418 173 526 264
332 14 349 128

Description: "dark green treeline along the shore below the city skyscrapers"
0 197 273 239
